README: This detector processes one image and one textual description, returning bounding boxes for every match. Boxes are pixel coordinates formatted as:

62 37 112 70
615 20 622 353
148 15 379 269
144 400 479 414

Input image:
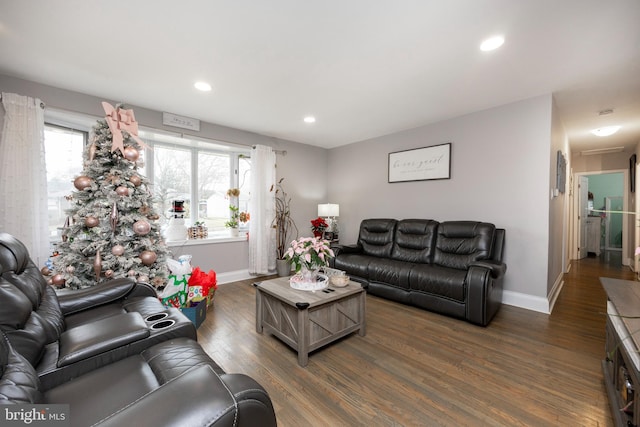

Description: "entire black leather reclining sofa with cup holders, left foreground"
0 233 276 426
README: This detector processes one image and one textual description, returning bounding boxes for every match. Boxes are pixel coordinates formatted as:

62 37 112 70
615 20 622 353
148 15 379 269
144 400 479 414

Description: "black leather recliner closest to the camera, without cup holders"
0 334 276 427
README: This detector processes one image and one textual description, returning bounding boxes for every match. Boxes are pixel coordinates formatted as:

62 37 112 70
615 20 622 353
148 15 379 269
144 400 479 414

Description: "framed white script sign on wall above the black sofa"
388 142 451 183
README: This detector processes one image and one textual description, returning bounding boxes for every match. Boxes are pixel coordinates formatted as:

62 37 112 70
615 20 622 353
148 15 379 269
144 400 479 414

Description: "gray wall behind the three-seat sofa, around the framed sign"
328 95 555 311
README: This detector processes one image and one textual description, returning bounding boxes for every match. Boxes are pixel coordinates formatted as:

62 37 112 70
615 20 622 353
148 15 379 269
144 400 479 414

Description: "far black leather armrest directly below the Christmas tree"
58 278 157 316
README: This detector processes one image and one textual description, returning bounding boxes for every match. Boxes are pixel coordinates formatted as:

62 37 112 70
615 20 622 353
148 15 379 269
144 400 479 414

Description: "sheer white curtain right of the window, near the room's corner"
249 145 276 274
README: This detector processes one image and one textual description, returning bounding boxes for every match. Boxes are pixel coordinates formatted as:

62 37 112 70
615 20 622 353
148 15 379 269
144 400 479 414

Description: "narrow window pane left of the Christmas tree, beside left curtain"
44 124 87 241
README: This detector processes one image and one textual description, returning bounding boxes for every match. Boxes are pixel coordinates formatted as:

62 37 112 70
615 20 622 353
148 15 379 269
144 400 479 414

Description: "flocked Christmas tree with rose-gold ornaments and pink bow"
52 102 168 289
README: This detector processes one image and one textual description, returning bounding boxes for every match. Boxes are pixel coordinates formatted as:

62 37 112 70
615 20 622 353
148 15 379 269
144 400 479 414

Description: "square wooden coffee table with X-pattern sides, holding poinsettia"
255 277 366 366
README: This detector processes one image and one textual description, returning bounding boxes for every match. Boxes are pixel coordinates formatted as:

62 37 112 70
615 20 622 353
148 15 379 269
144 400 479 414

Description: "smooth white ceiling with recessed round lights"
0 0 640 151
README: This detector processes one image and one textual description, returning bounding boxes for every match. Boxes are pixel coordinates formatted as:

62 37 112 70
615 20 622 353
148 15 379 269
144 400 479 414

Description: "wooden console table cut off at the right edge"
600 277 640 427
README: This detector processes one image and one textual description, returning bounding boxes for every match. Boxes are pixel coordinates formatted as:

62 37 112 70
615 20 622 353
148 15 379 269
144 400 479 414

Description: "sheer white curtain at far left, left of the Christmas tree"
0 92 50 266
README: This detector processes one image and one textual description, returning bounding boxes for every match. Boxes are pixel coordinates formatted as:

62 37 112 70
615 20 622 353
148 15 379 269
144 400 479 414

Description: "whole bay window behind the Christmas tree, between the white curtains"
45 109 251 242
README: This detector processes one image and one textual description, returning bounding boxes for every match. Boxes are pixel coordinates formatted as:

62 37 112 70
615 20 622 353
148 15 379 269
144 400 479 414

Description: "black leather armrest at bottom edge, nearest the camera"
94 365 276 427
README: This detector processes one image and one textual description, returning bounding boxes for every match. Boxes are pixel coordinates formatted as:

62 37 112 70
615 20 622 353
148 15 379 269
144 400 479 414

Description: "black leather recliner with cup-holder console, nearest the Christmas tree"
0 233 197 389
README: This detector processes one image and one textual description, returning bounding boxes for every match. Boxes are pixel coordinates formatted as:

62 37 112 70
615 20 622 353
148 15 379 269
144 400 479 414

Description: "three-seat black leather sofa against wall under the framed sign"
330 218 507 326
